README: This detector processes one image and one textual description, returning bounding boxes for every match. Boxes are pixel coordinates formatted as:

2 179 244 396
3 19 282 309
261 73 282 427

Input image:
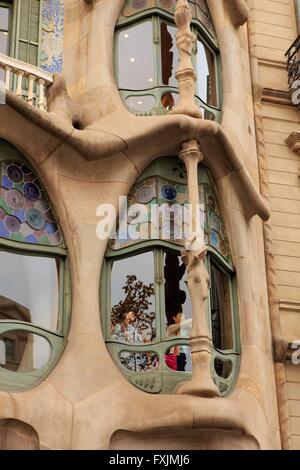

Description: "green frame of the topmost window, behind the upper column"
115 4 222 121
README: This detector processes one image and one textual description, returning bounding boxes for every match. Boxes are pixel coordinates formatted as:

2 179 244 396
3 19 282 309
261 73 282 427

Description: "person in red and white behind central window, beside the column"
165 312 192 372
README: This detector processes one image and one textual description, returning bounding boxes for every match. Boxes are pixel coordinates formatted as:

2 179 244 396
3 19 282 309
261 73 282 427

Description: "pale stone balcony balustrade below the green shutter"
0 54 53 111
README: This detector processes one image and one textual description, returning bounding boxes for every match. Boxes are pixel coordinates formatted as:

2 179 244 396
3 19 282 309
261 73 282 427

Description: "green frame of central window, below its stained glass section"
100 241 240 396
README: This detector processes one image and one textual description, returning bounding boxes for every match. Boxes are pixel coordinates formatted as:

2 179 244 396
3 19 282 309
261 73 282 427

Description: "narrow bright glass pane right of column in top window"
196 40 217 106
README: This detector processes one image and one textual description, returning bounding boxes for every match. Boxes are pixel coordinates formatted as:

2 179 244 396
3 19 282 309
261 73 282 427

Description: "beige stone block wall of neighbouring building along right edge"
253 0 300 449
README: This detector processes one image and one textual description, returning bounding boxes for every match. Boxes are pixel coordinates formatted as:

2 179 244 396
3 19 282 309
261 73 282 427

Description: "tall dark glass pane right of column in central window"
210 263 233 351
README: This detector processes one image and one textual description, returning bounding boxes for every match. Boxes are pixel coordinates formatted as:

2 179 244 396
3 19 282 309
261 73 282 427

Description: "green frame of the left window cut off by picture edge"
0 140 71 391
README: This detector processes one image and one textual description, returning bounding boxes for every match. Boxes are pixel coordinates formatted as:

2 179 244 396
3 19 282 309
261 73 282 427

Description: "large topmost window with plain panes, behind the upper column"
116 0 220 120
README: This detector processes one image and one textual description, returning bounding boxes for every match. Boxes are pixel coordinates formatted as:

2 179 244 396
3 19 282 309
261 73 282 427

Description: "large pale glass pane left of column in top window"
118 21 156 90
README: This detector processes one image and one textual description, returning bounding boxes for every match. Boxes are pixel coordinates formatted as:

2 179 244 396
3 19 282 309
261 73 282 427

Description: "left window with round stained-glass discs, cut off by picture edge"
0 141 69 390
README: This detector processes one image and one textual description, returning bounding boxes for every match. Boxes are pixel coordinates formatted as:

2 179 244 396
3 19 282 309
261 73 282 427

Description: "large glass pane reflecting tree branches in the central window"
111 252 156 343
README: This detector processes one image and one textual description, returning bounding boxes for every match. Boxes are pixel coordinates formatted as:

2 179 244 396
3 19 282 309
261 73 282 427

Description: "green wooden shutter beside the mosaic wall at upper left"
15 0 42 65
